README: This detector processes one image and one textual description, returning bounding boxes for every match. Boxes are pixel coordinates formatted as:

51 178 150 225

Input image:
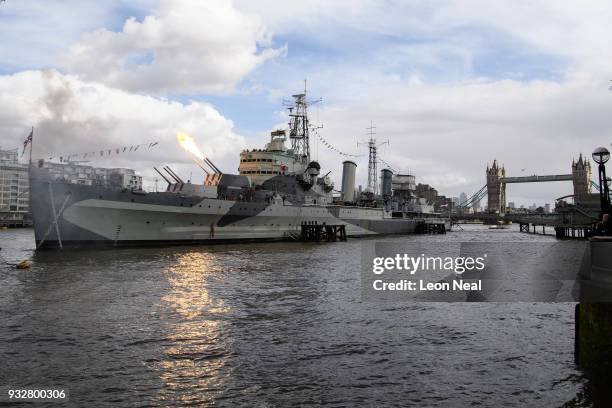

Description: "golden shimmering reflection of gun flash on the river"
155 252 229 404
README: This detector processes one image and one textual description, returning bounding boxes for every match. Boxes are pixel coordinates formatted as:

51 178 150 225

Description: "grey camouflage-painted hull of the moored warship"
30 177 417 249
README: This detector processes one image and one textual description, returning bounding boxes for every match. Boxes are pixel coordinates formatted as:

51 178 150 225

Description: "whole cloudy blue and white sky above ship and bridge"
0 0 612 206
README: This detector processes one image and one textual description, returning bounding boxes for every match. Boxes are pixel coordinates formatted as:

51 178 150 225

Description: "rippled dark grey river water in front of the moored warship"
0 226 604 406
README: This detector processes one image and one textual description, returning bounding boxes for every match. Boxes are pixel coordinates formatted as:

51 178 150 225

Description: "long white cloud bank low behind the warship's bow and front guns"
0 70 245 182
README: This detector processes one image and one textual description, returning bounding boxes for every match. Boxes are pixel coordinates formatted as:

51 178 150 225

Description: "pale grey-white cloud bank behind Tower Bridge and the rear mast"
304 73 612 204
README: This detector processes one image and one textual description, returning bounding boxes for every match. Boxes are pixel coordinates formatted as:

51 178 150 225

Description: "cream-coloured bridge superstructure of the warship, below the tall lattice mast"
238 130 304 185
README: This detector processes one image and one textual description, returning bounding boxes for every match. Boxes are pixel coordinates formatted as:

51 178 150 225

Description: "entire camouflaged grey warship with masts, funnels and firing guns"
29 91 444 249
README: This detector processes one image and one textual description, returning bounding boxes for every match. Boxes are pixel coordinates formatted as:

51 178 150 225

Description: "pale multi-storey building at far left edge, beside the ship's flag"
0 149 31 227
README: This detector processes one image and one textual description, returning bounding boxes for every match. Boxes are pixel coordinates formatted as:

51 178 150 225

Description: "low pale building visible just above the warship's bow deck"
39 160 142 190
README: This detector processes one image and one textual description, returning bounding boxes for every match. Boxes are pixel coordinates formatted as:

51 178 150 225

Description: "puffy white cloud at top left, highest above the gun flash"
66 0 285 94
